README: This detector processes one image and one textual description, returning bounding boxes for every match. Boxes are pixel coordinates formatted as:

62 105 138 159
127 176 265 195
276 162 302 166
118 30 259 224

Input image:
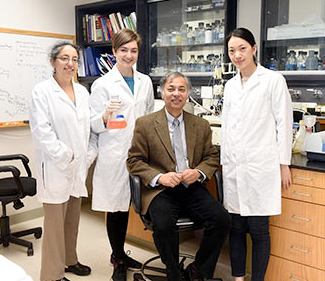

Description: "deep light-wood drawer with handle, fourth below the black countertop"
270 226 325 270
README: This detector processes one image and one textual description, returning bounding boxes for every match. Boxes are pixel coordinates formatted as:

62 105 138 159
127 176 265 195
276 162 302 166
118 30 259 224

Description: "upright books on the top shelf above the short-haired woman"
82 12 137 43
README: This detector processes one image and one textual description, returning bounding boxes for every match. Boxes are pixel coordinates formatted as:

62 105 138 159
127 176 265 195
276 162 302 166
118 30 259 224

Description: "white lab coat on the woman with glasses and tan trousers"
30 77 90 204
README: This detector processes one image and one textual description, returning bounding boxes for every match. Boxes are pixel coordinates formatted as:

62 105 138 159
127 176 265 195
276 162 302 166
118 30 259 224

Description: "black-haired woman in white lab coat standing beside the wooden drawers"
221 28 292 281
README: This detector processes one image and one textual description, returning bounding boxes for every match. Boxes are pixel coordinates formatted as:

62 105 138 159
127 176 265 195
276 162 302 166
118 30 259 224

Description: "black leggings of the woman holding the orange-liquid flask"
106 209 129 261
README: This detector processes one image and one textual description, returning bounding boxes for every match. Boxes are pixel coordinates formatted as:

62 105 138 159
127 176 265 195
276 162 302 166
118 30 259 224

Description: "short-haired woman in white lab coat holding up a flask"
90 29 154 281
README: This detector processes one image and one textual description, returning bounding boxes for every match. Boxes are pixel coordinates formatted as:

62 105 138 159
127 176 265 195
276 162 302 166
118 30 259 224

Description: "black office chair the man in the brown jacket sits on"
130 171 223 281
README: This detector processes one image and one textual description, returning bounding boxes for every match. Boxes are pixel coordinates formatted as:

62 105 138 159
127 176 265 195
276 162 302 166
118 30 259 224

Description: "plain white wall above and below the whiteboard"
0 0 102 214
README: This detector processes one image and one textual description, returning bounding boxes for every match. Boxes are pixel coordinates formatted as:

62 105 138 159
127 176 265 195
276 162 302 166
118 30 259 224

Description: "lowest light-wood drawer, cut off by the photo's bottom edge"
265 256 325 281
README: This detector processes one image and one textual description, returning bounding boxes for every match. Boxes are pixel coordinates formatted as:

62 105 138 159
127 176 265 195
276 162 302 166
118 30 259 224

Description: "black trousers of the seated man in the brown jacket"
148 183 230 281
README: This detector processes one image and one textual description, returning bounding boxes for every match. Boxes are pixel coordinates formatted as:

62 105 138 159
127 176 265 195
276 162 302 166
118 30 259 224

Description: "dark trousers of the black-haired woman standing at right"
229 214 270 281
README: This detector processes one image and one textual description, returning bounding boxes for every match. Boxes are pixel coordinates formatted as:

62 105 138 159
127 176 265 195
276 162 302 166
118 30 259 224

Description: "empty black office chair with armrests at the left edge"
0 154 42 256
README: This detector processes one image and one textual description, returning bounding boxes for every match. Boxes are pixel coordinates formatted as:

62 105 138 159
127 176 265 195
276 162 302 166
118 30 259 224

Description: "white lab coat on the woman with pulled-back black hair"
221 65 292 216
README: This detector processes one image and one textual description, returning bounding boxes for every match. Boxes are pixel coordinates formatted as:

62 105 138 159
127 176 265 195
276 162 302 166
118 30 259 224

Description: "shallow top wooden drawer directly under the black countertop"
291 168 325 189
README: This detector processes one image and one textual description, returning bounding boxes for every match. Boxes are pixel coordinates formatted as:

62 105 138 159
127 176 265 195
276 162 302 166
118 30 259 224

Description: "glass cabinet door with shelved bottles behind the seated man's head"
148 0 237 76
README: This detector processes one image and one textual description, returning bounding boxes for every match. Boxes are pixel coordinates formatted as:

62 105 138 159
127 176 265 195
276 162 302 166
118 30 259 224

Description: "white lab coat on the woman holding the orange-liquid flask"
90 66 154 212
